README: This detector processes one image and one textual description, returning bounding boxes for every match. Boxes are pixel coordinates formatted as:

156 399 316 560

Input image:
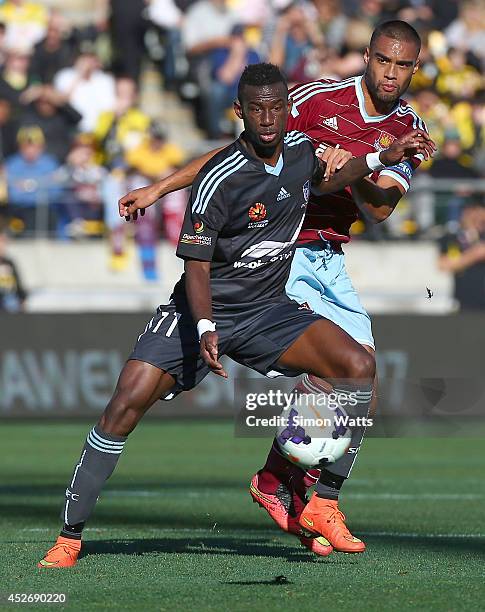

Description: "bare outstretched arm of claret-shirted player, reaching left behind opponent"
118 147 224 221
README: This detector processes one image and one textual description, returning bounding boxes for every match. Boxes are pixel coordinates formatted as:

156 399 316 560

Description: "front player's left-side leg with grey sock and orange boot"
37 360 175 568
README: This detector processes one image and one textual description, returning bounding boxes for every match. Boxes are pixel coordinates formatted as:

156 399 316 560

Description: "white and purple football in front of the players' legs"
276 396 352 469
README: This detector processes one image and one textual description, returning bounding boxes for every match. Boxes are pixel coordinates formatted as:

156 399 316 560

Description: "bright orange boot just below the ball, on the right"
300 493 365 553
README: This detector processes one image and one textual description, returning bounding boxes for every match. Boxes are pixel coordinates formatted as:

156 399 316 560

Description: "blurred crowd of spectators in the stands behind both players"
0 0 485 279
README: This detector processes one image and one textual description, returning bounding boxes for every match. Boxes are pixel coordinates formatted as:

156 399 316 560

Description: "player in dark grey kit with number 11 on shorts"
39 64 430 568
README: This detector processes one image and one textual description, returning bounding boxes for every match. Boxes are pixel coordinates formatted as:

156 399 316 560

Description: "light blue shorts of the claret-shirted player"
286 242 375 350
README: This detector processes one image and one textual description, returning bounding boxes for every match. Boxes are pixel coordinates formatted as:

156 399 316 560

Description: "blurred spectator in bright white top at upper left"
54 41 116 132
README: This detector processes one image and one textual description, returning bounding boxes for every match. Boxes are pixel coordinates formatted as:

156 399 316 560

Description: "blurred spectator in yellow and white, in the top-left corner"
0 0 47 50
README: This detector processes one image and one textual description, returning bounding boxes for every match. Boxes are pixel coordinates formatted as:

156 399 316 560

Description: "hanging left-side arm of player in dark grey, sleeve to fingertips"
177 159 228 378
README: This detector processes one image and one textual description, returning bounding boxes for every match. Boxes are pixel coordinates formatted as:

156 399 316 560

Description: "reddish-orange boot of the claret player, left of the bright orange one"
249 474 333 557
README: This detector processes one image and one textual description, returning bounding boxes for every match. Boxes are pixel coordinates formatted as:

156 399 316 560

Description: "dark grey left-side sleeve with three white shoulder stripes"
177 172 228 261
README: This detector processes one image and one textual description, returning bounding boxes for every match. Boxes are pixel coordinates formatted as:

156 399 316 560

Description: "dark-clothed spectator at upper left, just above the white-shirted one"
29 11 75 83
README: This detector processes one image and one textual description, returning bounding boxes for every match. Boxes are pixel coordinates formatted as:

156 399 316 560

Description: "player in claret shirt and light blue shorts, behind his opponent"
120 21 434 552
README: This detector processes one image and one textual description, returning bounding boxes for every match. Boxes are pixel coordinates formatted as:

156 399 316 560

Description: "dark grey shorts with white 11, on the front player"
129 295 323 399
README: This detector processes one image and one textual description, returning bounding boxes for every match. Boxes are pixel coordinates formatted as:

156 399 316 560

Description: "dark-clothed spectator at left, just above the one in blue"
20 85 81 162
